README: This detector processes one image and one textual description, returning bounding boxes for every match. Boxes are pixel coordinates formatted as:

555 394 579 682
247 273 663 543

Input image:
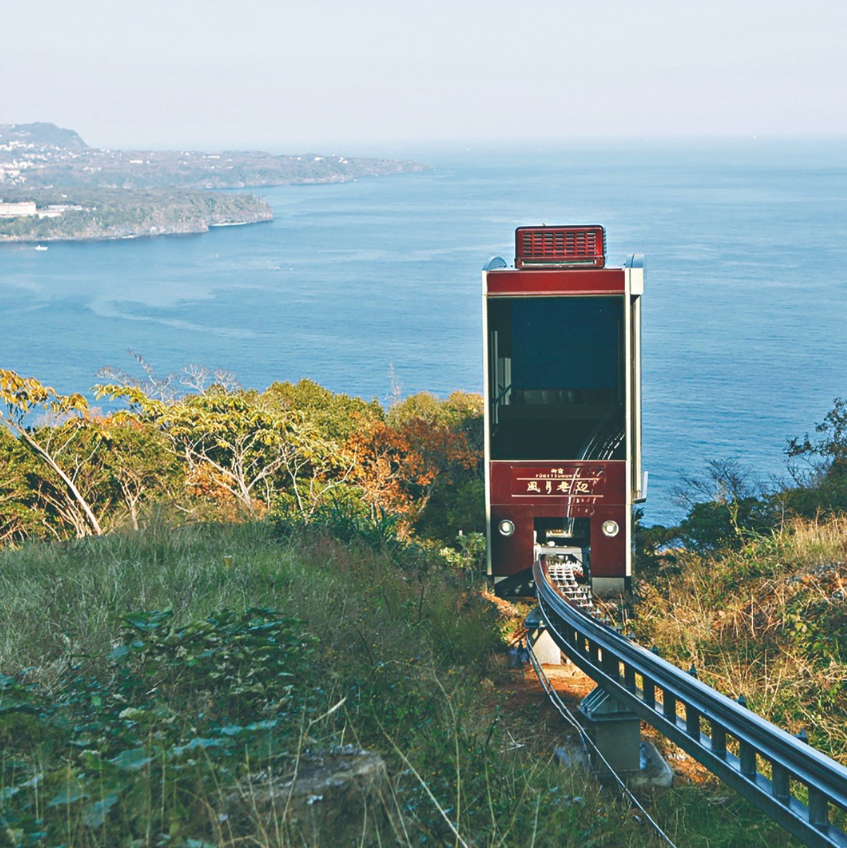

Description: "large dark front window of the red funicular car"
488 296 625 460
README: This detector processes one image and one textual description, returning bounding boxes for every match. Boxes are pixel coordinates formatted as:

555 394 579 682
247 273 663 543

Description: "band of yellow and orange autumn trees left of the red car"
0 368 482 542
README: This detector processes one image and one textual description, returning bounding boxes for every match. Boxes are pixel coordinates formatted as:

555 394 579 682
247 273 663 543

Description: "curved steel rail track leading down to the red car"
533 560 847 848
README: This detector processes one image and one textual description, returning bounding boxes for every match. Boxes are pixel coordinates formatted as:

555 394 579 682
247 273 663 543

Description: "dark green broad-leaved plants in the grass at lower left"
0 608 315 846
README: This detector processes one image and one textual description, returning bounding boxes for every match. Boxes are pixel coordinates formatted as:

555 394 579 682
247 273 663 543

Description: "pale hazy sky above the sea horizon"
6 0 847 152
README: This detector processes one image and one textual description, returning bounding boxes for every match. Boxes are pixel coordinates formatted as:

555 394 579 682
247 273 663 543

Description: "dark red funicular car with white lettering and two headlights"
482 226 646 596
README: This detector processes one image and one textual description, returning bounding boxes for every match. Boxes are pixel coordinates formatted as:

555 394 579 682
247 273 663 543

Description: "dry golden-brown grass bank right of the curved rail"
635 517 847 762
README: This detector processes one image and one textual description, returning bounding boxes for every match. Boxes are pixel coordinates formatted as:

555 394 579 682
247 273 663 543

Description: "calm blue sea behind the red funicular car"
0 139 847 521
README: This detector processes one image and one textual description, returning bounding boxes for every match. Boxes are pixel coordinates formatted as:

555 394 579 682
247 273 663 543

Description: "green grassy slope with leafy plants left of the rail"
0 522 816 848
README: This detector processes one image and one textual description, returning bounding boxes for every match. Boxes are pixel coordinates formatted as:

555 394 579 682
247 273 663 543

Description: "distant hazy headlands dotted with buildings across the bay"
0 123 429 244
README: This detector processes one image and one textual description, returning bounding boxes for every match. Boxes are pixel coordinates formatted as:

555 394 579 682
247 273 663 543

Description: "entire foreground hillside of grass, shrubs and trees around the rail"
0 358 847 848
